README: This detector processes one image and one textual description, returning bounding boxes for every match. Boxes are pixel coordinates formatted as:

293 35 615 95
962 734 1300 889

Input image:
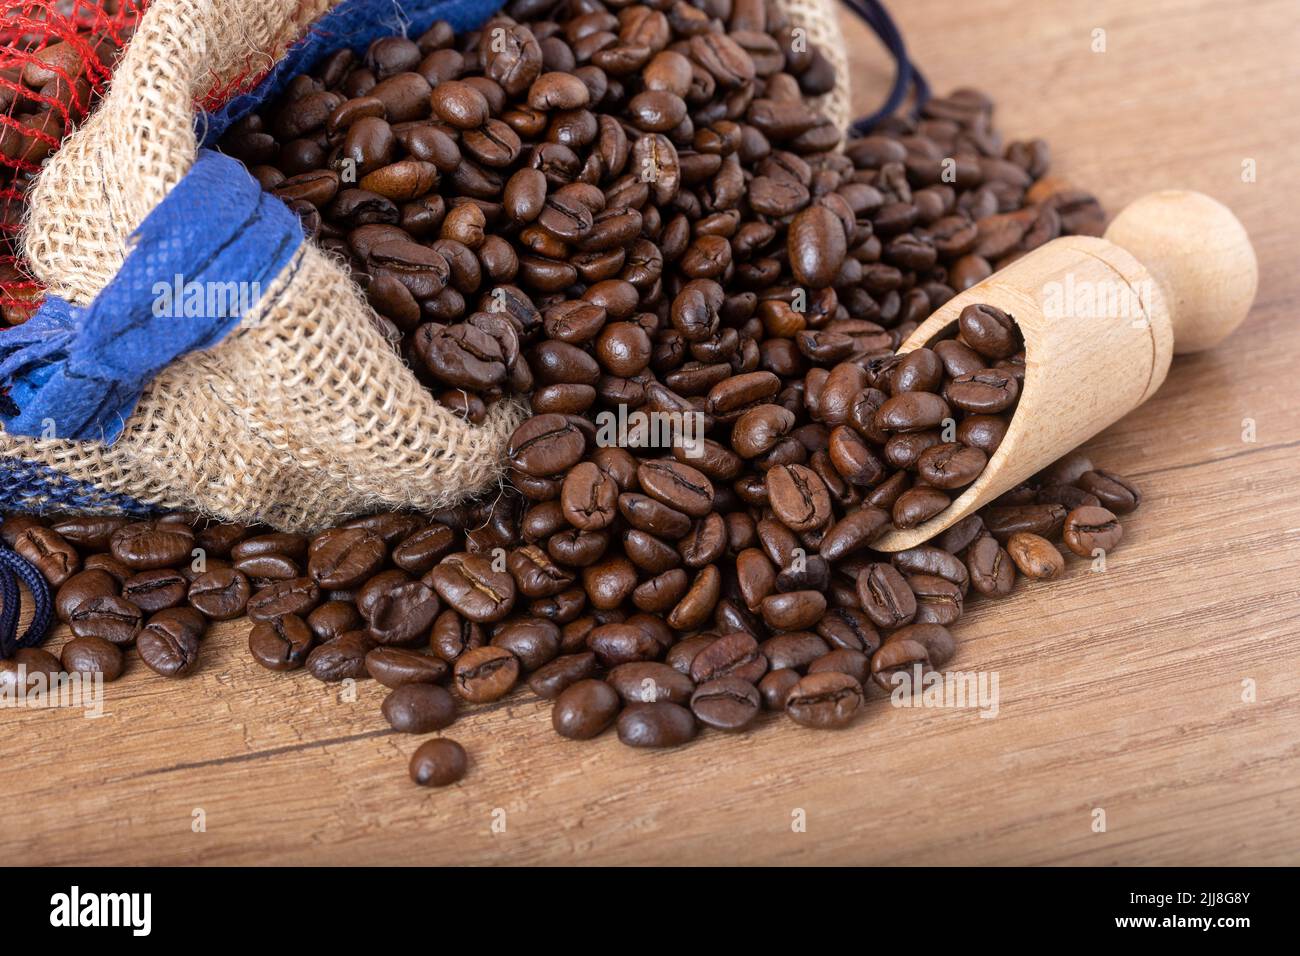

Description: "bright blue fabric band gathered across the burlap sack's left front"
0 150 303 444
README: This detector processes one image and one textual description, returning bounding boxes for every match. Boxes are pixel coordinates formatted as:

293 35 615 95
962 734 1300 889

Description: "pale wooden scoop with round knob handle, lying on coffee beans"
871 190 1260 551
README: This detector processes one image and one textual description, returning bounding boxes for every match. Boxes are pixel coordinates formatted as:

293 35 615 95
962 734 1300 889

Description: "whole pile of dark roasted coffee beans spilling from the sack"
0 0 1139 786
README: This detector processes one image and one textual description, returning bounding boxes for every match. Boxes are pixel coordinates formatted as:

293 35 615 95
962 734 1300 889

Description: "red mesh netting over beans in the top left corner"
0 0 148 328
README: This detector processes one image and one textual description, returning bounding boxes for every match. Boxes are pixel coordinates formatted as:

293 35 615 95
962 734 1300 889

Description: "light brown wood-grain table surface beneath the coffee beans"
0 0 1300 864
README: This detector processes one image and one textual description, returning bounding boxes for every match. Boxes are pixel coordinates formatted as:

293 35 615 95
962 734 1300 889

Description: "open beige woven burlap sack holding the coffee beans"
0 0 848 531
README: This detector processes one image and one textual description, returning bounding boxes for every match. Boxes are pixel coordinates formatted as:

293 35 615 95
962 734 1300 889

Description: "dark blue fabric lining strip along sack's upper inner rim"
195 0 506 146
